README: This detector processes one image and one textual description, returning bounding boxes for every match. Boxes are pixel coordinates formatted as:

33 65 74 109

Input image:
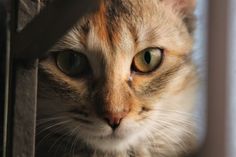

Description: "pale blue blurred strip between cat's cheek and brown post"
193 0 208 143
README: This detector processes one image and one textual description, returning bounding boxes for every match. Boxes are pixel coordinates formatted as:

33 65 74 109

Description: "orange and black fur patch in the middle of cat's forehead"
91 0 136 49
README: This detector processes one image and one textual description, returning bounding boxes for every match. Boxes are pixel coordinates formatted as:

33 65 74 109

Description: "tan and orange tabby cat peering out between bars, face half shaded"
19 0 198 157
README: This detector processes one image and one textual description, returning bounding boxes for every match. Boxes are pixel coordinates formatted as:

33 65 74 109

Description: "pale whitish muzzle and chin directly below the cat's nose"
66 110 145 150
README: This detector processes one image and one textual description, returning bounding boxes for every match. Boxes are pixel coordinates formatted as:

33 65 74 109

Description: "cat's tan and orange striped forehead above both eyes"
54 0 192 56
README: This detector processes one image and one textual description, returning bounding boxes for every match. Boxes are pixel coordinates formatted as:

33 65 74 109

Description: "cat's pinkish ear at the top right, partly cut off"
161 0 196 33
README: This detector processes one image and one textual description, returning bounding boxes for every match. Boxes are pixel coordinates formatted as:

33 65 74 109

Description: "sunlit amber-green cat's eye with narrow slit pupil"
132 48 163 73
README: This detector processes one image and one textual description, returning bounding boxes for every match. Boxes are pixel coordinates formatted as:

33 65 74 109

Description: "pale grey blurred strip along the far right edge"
228 0 236 157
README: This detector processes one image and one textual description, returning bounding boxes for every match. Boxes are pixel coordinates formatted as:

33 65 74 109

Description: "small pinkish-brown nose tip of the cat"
104 112 128 130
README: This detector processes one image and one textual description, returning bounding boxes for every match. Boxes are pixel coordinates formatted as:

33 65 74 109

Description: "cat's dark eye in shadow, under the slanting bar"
56 50 89 76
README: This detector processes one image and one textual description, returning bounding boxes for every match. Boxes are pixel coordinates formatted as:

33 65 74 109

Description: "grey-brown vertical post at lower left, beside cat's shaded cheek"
12 60 38 157
